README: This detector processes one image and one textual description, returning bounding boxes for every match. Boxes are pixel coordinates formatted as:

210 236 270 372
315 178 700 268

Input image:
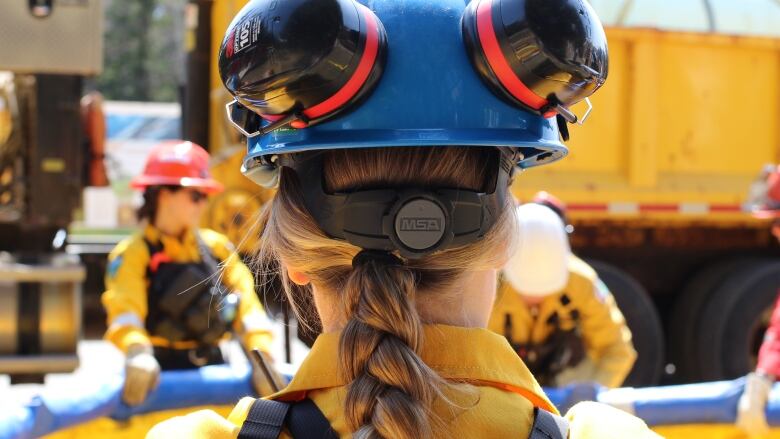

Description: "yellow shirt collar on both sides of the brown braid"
271 325 557 413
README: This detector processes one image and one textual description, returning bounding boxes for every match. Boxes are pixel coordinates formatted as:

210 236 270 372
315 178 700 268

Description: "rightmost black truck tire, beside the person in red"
697 261 780 380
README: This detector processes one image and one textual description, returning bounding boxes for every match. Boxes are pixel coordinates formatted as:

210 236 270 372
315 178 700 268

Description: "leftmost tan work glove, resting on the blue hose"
122 344 160 406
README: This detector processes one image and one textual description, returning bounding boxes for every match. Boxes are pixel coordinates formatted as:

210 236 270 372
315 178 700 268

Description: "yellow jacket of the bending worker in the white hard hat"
488 256 636 387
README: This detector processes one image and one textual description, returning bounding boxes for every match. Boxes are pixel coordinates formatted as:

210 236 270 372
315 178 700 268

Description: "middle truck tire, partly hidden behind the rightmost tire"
668 258 759 382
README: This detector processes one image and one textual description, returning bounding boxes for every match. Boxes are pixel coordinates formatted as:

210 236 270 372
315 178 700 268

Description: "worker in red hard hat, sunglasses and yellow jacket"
102 141 280 405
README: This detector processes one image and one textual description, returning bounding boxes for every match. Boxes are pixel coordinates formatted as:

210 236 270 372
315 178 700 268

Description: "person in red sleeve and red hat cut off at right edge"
737 165 780 436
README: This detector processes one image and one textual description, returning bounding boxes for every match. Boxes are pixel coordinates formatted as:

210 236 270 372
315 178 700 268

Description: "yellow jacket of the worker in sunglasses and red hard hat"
102 226 273 352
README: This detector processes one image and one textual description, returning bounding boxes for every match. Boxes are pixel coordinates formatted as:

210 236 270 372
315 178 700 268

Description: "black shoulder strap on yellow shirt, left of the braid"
238 399 339 439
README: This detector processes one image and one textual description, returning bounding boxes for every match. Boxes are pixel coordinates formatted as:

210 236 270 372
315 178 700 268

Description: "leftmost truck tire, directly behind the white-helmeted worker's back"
588 261 664 386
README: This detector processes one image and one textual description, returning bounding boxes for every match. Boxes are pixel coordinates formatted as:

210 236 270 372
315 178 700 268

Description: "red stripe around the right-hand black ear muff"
477 0 544 111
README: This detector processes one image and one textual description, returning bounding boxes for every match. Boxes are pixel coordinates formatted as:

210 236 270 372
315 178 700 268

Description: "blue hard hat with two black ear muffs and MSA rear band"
219 0 607 256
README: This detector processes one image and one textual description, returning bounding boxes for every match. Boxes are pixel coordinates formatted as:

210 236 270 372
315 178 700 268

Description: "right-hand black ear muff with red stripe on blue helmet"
462 0 608 122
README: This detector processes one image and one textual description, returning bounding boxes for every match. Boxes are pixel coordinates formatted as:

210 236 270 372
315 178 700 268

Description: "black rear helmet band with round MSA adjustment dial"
281 150 516 259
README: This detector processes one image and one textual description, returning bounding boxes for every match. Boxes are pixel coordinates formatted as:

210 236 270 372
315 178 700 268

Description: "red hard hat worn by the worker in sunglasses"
130 140 223 193
